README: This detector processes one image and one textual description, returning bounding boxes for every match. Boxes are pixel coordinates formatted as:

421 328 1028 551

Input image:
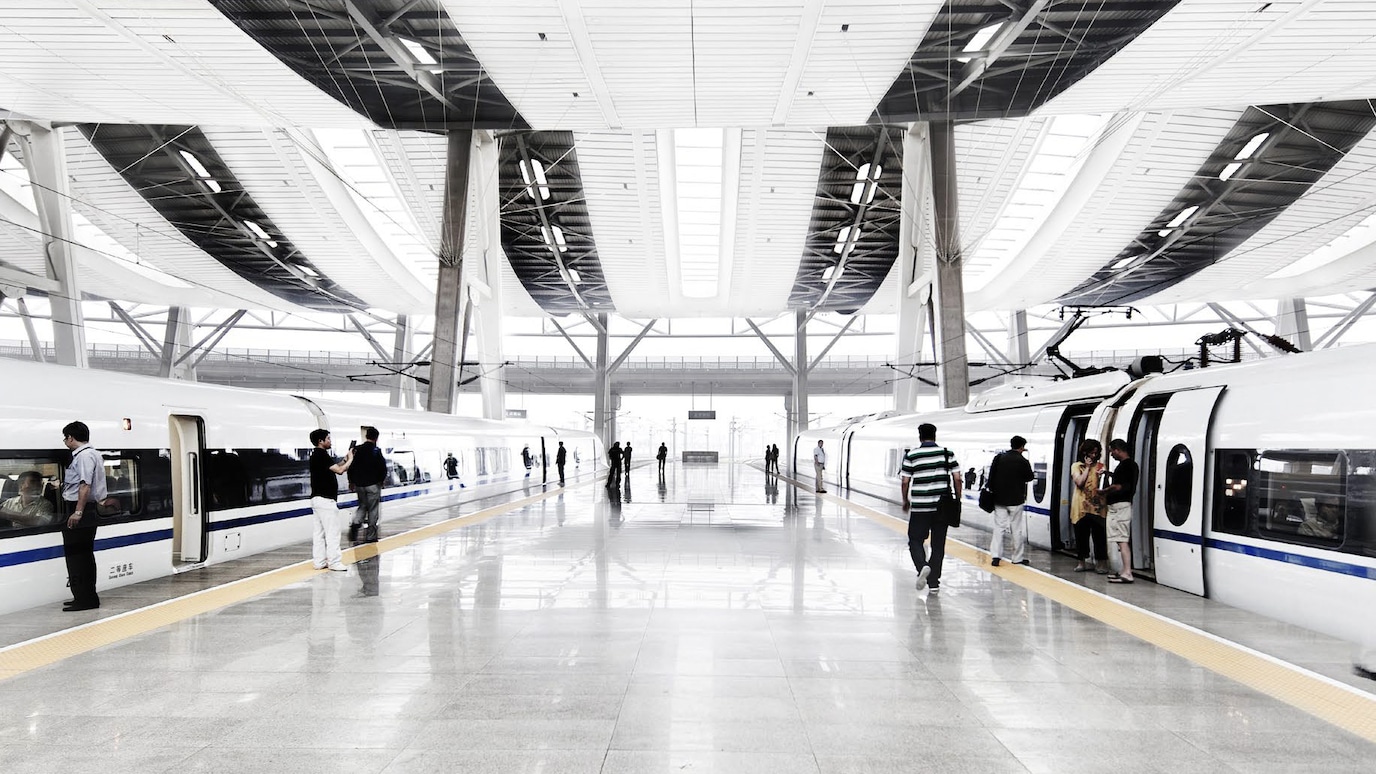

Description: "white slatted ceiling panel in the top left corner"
0 0 366 127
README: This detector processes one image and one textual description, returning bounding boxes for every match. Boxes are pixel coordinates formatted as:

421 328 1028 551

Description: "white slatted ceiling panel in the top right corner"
1043 0 1376 113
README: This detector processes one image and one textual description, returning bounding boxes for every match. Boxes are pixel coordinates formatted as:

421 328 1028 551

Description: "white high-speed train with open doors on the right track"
794 346 1376 642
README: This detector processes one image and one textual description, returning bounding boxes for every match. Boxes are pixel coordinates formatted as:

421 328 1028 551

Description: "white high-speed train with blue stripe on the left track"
0 361 605 613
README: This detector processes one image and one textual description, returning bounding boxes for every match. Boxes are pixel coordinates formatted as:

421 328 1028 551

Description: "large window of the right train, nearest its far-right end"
1255 452 1346 547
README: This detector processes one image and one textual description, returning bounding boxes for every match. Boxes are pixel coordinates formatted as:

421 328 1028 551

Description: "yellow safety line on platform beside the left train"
0 477 583 682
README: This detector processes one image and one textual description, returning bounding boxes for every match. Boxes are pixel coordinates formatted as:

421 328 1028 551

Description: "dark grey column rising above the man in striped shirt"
929 121 970 408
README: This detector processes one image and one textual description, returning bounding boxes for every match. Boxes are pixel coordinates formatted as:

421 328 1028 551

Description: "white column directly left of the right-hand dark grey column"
893 123 932 412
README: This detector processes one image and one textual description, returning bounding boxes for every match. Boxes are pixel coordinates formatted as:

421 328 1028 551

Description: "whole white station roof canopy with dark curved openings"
0 0 1376 318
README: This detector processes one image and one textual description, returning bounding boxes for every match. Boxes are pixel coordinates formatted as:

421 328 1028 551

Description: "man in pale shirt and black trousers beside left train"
62 421 107 613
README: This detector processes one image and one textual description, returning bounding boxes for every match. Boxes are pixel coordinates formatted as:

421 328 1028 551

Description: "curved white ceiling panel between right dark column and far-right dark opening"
966 110 1243 311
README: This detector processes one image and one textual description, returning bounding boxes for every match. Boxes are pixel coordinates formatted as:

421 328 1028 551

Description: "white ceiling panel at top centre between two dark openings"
446 0 943 129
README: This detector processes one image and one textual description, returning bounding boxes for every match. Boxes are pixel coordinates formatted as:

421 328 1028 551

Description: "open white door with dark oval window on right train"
1143 387 1223 595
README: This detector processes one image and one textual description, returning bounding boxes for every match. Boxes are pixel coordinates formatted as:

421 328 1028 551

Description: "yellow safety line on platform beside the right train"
795 482 1376 742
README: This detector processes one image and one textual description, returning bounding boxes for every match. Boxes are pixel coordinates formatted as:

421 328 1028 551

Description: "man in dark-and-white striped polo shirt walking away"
900 423 960 594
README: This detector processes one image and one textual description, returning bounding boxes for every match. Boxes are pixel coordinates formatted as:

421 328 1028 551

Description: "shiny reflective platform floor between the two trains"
0 464 1376 774
